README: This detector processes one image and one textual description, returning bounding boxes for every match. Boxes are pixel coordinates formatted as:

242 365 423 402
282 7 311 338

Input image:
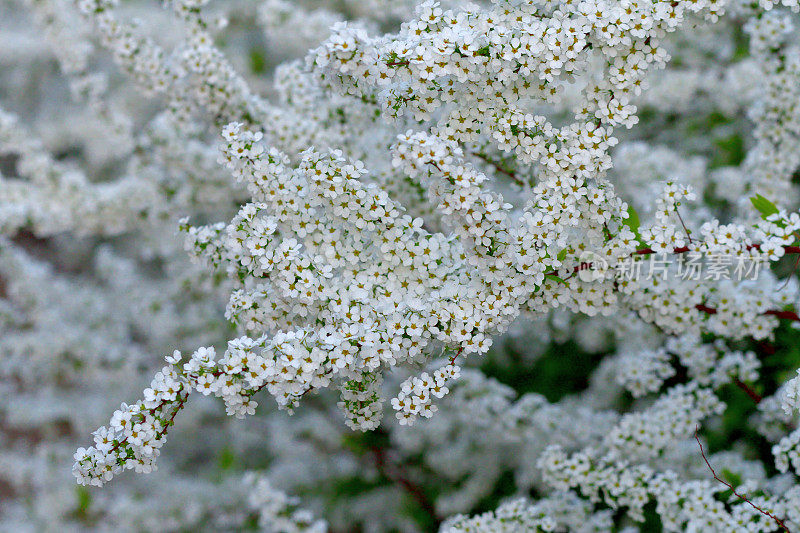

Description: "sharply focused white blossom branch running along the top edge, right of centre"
310 0 721 138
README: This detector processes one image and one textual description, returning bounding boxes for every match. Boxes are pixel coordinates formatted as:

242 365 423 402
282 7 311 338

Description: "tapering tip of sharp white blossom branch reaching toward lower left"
74 331 350 485
